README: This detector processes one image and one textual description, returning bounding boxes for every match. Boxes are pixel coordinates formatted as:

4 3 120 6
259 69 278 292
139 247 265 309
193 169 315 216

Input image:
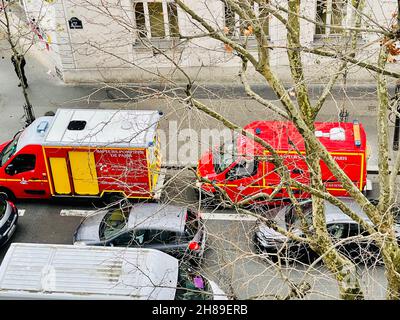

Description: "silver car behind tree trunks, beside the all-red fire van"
254 198 400 263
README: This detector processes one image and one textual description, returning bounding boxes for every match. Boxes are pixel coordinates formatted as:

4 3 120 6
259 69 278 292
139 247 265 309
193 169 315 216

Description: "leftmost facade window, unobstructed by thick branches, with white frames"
133 0 179 39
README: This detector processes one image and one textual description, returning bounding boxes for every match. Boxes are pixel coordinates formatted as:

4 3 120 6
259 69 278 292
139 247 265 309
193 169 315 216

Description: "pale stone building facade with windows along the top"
21 0 397 83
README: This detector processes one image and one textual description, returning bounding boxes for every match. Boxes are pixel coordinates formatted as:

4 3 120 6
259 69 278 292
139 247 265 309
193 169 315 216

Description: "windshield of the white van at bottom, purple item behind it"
175 265 213 300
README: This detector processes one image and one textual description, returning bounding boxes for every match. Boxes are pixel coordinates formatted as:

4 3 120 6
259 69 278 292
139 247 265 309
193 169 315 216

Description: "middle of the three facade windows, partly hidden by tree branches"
224 2 270 37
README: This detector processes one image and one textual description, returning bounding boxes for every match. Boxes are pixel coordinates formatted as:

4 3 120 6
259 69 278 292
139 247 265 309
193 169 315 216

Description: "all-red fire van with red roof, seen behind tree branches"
197 121 367 205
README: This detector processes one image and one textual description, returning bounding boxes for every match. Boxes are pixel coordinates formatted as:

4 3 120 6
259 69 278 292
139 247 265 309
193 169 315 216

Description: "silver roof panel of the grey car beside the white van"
128 203 187 232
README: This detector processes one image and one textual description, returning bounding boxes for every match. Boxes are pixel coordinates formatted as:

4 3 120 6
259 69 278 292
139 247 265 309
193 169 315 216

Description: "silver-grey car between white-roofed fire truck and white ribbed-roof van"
73 203 206 262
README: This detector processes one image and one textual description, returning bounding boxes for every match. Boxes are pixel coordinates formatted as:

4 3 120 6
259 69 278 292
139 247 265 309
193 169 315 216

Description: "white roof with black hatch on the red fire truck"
43 109 161 148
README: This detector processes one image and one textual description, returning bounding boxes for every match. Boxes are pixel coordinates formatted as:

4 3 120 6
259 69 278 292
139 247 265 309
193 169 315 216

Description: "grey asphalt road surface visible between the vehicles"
0 171 385 299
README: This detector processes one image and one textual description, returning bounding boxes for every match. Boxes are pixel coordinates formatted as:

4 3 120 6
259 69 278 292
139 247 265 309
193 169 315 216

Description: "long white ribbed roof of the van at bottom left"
0 243 178 300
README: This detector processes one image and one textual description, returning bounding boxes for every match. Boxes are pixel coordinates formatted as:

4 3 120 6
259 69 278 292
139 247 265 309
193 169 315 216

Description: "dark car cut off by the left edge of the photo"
0 194 18 247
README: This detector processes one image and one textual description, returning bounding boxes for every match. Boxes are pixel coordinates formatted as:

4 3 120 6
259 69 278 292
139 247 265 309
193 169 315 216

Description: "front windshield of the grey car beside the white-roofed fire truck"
99 209 129 240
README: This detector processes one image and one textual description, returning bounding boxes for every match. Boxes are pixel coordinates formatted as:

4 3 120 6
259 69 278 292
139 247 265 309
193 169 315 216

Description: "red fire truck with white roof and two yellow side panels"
0 109 162 199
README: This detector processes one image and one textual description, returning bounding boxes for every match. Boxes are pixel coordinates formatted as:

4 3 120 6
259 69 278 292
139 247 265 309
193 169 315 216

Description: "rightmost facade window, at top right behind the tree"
315 0 347 36
